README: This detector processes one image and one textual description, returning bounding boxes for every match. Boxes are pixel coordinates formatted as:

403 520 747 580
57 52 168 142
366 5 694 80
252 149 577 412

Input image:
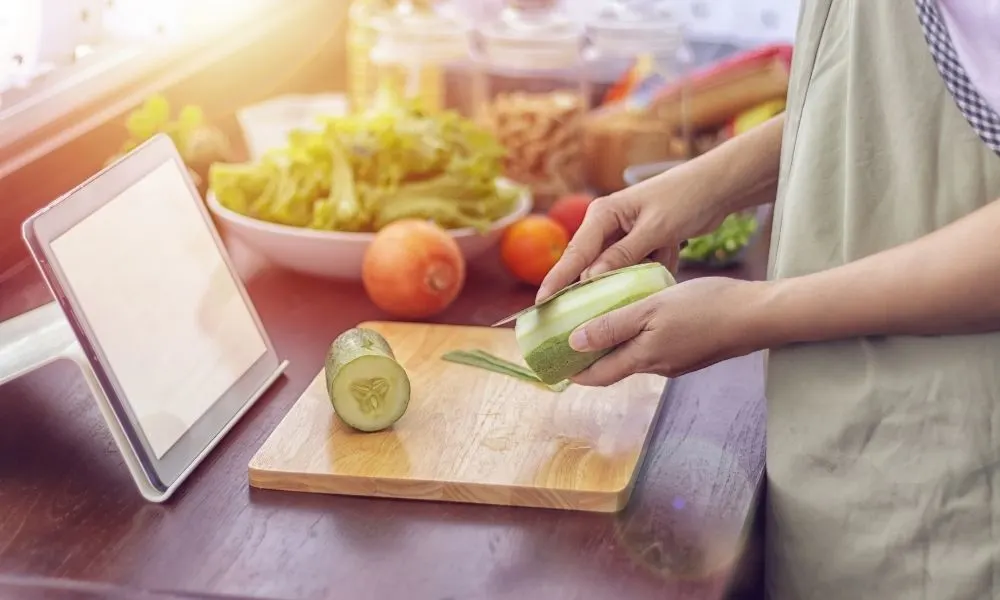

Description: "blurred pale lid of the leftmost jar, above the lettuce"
371 2 469 64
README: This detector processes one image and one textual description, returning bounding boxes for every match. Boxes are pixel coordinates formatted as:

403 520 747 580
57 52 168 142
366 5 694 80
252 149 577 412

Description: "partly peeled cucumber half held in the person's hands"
514 263 677 385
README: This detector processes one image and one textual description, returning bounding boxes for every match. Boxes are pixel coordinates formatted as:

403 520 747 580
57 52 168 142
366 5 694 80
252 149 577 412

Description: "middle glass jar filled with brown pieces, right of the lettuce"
474 0 590 211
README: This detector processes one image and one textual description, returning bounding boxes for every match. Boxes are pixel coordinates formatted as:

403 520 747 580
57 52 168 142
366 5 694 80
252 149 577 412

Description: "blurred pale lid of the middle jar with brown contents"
479 0 584 70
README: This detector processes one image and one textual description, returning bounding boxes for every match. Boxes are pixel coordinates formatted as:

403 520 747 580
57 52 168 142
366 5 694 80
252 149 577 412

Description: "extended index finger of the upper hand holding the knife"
535 198 621 302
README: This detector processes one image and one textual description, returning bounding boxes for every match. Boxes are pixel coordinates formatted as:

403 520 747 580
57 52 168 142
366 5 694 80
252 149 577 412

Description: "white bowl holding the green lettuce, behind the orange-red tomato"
206 183 532 280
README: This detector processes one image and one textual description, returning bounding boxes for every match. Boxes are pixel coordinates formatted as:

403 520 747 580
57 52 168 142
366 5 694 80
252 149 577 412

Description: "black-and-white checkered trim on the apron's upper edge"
916 0 1000 154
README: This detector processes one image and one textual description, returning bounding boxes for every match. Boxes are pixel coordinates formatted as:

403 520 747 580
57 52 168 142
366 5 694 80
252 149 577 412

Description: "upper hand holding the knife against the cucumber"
535 163 727 302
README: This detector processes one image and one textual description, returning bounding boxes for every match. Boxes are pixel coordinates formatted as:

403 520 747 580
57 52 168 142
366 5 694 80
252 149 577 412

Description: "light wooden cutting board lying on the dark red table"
250 322 666 512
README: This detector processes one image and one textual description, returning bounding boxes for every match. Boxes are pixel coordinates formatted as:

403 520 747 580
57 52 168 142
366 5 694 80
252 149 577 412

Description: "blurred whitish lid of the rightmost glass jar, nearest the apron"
586 0 684 56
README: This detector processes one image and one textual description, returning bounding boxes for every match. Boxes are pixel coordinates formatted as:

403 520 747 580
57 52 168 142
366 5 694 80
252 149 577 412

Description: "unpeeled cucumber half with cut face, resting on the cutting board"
325 327 410 432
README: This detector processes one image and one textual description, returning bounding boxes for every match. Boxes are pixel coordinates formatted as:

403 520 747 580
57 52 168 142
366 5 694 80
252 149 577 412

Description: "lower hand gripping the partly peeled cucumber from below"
569 277 766 386
